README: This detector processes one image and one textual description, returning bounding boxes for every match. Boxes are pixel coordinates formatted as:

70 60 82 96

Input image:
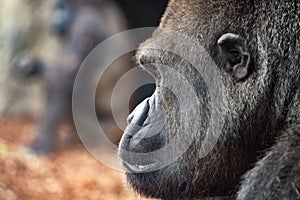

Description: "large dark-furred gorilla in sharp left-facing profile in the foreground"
119 0 300 200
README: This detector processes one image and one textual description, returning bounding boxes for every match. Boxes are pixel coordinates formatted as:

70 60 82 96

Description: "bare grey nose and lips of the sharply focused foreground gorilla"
119 91 167 173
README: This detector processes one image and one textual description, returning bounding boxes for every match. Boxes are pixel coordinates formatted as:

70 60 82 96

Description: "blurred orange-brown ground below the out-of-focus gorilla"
0 119 150 200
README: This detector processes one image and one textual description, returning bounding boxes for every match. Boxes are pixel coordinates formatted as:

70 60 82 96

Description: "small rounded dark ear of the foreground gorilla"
218 33 252 81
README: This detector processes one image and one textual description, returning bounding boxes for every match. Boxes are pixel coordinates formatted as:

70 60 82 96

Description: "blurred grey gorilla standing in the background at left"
12 0 129 154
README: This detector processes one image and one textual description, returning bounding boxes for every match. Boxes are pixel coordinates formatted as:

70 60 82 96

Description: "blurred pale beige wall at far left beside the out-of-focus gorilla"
0 0 54 116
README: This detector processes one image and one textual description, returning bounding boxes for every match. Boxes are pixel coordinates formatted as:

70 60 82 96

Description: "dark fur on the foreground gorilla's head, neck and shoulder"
120 0 300 199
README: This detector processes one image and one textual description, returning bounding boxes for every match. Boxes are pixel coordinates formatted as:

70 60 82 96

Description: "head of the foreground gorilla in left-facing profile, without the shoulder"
119 0 298 199
